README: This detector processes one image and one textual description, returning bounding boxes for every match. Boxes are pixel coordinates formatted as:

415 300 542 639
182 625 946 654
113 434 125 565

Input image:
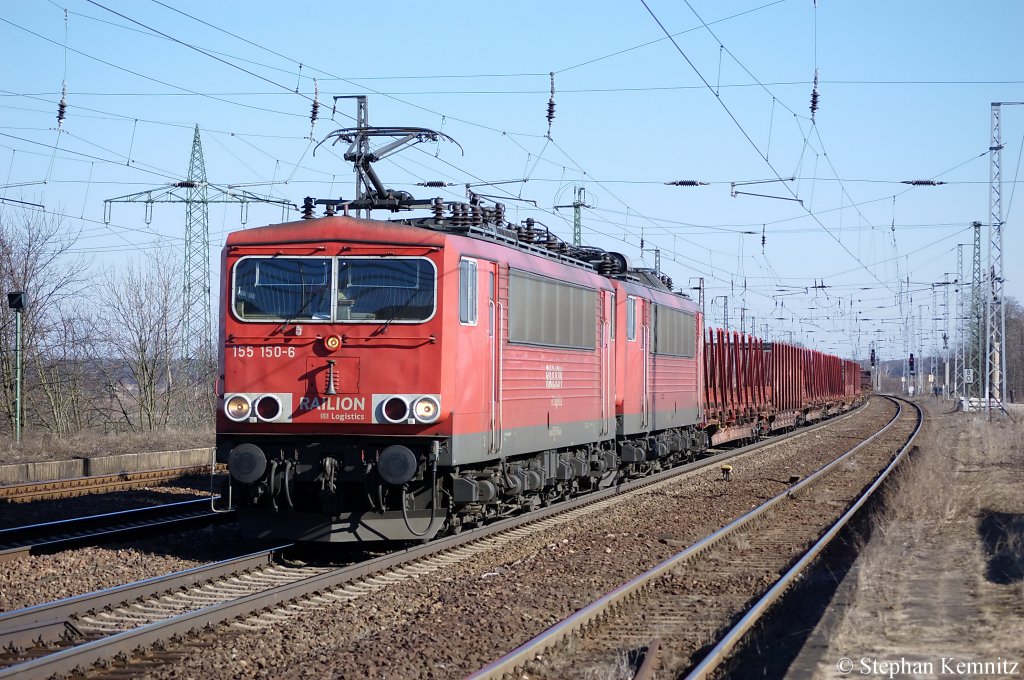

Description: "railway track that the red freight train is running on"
0 405 868 678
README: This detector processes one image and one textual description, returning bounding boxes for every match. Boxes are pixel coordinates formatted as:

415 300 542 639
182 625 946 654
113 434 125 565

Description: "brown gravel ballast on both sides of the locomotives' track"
0 399 893 678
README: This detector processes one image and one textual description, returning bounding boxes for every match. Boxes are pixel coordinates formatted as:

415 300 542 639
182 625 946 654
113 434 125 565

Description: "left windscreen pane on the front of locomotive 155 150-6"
233 257 331 321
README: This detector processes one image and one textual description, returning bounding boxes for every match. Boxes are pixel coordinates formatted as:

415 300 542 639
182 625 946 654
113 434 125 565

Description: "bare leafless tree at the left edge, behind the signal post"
0 209 91 438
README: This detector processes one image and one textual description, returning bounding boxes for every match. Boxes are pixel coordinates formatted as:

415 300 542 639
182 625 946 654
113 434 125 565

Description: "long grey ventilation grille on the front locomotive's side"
509 270 597 349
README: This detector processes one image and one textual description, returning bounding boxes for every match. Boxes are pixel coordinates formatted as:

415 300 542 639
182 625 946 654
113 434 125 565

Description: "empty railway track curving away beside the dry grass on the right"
471 397 924 679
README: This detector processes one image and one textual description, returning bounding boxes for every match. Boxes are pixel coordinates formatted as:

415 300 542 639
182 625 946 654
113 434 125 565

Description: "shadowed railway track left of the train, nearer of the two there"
0 497 234 562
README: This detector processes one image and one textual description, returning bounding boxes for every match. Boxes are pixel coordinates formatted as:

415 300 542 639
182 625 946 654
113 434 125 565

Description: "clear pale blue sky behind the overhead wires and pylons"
0 0 1024 356
